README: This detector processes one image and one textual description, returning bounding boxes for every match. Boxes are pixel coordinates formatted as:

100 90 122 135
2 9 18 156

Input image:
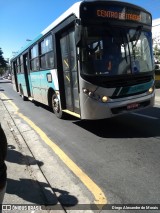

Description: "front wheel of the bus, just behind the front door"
52 93 64 118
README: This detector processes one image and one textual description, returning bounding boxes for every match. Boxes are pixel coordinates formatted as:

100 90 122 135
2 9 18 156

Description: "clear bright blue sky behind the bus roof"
0 0 160 59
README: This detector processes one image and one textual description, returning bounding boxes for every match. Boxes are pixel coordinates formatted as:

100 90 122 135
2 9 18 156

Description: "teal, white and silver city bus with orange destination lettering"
11 0 155 120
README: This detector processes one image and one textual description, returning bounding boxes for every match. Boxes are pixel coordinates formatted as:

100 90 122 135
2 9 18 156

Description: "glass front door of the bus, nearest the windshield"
60 31 79 113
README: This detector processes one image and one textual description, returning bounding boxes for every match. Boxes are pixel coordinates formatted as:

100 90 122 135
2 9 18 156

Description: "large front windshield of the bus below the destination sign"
81 26 154 76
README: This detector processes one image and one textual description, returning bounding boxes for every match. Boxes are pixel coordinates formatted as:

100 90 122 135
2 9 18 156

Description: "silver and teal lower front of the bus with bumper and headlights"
80 79 155 119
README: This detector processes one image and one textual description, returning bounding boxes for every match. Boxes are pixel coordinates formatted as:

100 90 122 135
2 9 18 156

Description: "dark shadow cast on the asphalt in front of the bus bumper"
74 107 160 138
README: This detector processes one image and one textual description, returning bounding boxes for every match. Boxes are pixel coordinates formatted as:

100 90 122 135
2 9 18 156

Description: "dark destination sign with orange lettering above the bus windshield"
80 2 152 25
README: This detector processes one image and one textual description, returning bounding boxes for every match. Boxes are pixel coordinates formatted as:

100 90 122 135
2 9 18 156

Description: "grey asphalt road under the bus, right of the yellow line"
0 80 160 208
